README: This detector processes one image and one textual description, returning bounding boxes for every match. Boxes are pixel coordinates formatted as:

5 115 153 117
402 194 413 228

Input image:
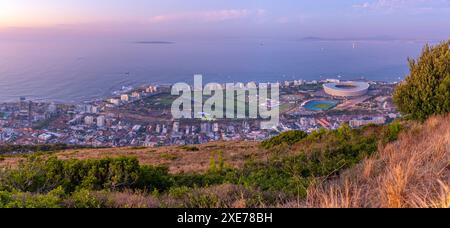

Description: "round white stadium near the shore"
323 81 370 97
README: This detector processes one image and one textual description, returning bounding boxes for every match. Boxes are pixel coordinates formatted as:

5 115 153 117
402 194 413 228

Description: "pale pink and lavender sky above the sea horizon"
0 0 450 39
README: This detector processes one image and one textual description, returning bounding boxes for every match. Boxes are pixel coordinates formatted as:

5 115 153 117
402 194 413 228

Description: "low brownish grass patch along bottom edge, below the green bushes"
71 184 285 208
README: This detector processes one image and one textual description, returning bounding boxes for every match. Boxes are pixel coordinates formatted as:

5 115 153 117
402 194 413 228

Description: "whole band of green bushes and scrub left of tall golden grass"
0 119 401 207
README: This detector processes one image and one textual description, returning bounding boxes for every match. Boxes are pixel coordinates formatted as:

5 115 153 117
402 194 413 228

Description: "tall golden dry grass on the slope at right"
306 115 450 208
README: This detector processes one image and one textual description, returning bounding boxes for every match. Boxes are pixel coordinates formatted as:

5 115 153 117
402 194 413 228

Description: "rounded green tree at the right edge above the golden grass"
394 40 450 121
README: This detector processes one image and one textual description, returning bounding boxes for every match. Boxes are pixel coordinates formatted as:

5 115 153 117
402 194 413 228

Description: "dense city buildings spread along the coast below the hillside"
0 79 399 150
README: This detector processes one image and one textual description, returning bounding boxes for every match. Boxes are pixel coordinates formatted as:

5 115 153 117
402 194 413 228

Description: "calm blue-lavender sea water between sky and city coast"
0 39 424 102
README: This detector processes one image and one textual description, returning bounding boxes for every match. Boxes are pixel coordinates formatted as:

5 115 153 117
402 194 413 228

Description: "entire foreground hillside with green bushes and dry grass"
0 115 450 208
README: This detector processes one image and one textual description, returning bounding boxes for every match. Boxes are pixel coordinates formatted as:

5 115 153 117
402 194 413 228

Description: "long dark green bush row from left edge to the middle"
0 156 236 197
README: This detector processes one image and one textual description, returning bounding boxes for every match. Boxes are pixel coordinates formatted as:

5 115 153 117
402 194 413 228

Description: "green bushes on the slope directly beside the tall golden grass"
232 125 386 197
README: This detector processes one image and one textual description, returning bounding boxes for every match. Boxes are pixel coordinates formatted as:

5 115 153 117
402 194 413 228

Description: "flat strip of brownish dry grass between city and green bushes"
0 142 267 173
